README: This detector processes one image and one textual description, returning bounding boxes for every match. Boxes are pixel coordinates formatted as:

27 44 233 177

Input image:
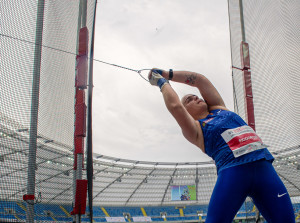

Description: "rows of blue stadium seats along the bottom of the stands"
0 201 300 222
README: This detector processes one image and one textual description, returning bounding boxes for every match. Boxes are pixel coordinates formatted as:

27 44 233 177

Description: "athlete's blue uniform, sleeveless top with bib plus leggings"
199 110 295 223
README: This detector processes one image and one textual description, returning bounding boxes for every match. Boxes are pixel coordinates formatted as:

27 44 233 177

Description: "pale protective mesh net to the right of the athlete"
228 0 300 205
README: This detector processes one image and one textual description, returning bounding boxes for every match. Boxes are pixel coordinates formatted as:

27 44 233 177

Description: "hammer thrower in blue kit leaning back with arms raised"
148 69 295 223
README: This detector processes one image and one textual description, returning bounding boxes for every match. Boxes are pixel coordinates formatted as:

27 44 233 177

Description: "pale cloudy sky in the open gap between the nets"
93 0 233 162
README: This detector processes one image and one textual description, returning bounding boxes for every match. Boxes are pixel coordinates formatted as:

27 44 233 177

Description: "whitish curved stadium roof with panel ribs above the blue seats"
0 113 300 206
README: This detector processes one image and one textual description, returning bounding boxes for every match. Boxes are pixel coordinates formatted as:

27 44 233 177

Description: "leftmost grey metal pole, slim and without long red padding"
26 0 45 223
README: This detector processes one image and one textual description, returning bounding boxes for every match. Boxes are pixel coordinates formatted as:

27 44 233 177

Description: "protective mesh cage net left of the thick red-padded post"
0 0 96 222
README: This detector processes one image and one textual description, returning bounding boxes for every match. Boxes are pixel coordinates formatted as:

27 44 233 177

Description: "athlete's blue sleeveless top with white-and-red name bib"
199 109 274 173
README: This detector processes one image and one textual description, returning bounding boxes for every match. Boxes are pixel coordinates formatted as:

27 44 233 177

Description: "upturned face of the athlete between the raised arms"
181 94 207 117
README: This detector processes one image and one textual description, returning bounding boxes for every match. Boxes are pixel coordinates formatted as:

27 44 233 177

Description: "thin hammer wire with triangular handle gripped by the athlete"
0 33 151 82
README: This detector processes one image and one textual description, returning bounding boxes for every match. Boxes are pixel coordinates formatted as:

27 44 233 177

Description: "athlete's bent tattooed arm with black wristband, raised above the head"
162 71 228 110
